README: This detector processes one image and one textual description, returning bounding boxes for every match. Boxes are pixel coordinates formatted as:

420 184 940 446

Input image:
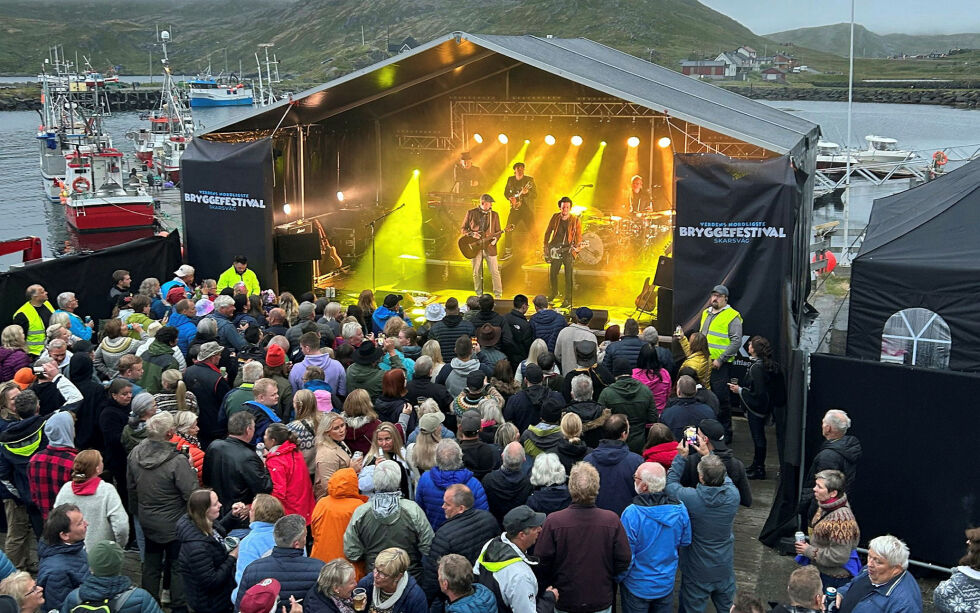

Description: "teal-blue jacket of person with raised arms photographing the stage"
664 454 739 583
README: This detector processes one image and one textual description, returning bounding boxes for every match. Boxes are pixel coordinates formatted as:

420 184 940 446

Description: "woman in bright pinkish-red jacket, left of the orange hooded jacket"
263 424 315 525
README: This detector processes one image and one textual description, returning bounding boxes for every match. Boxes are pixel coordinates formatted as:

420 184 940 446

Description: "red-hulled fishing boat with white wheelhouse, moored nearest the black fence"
61 145 155 232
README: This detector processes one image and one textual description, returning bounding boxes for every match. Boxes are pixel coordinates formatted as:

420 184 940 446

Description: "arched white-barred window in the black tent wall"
881 308 953 369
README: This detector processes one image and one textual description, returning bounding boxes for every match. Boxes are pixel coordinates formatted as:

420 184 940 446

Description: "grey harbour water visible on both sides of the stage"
0 101 980 269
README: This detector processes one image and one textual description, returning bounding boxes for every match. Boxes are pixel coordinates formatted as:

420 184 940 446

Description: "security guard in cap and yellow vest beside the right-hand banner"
700 285 742 446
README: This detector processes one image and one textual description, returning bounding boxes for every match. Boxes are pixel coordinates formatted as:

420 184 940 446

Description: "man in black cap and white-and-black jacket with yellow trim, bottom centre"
473 505 558 613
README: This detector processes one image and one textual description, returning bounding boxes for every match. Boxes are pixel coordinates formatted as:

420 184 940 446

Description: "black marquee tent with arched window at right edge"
847 160 980 371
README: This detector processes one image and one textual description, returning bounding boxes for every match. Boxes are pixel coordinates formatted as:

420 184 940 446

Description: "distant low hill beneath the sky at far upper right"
766 23 980 58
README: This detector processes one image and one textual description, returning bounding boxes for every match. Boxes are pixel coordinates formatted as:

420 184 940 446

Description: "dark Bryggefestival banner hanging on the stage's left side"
180 138 276 289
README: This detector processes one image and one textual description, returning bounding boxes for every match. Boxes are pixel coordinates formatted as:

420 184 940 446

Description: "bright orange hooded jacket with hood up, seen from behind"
310 468 367 580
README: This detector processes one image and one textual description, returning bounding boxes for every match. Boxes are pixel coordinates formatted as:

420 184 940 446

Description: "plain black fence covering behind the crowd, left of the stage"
0 231 180 325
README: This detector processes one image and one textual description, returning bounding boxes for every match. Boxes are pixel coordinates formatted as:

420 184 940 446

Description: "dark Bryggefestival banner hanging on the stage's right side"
672 154 801 367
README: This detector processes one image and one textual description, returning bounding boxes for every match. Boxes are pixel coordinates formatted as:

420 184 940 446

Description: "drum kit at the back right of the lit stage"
579 211 674 265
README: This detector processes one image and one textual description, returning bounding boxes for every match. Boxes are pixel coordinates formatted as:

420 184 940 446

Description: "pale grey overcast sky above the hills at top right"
700 0 980 34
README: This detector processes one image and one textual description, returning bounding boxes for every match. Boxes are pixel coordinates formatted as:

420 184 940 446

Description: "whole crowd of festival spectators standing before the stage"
0 256 968 613
